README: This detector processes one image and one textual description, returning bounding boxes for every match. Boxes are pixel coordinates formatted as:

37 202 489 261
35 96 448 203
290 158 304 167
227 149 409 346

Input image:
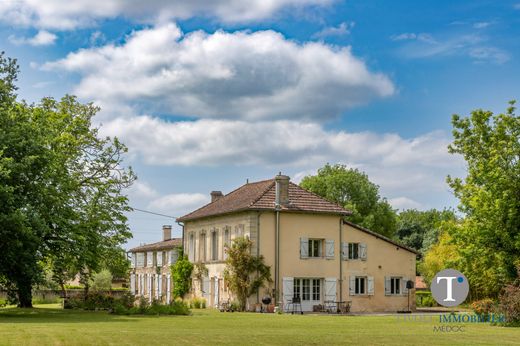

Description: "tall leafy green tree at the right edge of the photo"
447 101 520 297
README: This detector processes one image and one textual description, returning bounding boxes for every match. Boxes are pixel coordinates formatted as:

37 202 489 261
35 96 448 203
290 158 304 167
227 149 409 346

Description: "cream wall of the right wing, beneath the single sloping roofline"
343 225 416 312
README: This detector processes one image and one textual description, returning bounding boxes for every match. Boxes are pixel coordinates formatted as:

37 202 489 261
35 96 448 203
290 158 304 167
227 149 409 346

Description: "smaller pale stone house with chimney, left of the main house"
128 225 182 303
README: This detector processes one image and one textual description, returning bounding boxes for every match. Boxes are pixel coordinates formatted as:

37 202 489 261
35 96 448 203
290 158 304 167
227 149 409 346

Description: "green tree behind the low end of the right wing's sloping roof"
395 209 457 256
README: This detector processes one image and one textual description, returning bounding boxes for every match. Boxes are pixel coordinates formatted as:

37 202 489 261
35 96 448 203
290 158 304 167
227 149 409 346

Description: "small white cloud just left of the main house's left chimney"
148 193 210 217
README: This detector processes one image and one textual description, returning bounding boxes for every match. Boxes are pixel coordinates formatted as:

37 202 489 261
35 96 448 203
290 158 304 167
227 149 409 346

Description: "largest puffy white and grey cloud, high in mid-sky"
43 24 394 121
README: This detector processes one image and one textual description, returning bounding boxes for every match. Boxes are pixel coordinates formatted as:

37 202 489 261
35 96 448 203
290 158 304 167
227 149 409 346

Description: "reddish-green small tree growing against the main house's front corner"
224 237 272 311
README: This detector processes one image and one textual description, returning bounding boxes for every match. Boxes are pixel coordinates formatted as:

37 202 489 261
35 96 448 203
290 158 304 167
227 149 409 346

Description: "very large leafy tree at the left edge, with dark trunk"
0 53 135 307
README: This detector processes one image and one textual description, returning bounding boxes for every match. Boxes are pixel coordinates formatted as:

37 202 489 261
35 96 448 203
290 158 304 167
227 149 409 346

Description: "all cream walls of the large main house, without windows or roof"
184 211 415 311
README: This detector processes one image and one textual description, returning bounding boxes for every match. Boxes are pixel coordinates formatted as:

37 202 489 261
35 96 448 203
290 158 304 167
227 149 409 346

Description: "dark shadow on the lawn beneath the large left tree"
0 308 189 324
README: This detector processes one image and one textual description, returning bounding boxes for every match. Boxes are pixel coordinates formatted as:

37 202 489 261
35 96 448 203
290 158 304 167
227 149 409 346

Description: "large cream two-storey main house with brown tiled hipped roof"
177 175 417 312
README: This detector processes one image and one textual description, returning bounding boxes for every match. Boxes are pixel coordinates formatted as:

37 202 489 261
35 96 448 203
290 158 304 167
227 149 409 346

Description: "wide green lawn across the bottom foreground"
0 305 520 345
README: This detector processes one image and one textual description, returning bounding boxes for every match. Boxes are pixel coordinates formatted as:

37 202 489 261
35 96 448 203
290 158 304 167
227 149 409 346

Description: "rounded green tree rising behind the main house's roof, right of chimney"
300 164 397 237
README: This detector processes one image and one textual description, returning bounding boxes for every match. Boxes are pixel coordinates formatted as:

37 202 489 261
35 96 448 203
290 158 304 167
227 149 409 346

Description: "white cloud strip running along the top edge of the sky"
0 0 333 30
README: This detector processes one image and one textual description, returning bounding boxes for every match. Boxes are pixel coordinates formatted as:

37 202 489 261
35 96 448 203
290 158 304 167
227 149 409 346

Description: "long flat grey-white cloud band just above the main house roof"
101 116 462 196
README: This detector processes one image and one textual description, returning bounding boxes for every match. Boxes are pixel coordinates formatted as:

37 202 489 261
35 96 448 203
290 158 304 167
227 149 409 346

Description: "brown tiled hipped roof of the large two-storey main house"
177 179 351 221
